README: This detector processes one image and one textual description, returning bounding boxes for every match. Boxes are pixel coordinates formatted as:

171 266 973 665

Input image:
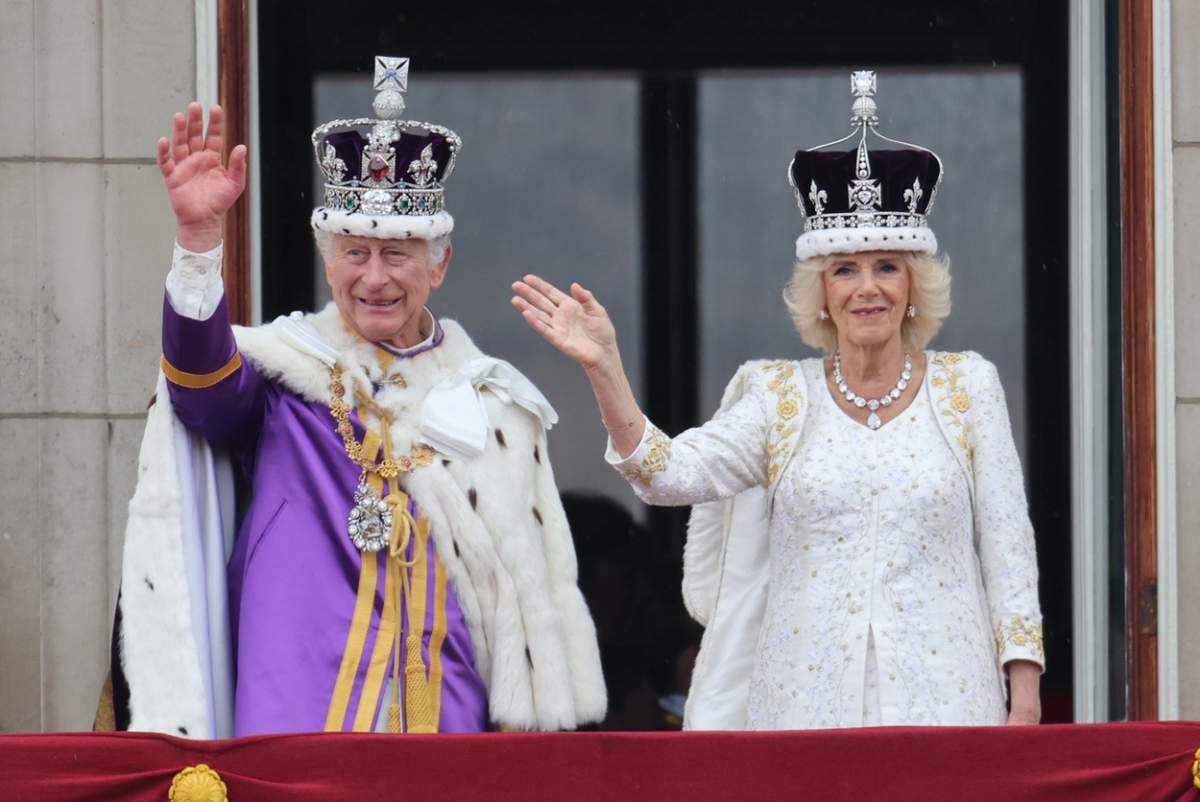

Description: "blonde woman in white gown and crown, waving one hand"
512 73 1044 729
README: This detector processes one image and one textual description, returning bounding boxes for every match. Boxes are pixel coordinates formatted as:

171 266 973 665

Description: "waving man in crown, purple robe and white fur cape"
102 58 605 737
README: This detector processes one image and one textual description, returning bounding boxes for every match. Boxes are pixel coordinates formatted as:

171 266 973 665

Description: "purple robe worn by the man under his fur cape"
162 292 487 736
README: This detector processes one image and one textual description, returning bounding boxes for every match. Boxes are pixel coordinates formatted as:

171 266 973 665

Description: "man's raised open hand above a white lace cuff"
158 103 246 251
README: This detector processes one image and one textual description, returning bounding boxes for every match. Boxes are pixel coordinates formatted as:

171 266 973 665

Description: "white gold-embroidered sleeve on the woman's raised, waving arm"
605 376 767 507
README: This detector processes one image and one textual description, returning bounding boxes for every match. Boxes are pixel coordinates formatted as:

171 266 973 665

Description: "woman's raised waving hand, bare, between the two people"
512 275 619 369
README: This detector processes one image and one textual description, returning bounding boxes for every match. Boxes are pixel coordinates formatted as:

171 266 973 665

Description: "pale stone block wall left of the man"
0 0 196 731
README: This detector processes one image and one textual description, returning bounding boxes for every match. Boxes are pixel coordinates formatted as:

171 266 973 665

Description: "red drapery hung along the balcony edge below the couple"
0 723 1200 802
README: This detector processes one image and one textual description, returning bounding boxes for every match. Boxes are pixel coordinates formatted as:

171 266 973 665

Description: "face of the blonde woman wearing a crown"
823 251 908 346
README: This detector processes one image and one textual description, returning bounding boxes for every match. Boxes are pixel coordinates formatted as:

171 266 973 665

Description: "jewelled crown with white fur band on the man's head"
312 55 462 239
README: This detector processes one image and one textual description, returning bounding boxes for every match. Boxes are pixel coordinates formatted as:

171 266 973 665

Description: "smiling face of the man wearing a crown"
325 234 451 347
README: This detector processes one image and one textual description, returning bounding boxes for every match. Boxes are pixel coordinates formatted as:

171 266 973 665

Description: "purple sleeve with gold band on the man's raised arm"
162 291 266 453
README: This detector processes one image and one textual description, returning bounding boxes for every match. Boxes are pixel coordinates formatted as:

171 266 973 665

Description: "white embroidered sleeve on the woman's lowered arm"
971 358 1045 669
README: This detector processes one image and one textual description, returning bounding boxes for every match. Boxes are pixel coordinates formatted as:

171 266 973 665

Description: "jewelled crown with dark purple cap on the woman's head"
787 70 942 259
